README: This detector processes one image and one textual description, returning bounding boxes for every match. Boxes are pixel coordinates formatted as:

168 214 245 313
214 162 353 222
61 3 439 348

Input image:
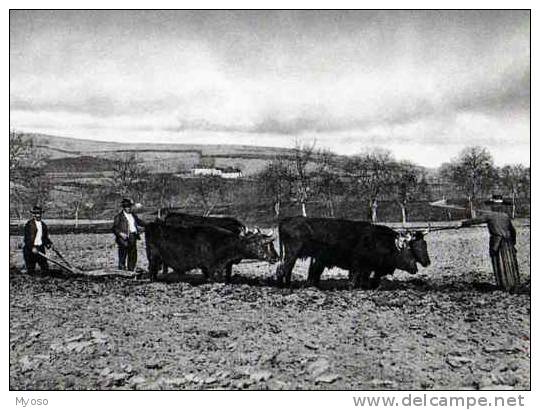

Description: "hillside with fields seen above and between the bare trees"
10 133 530 222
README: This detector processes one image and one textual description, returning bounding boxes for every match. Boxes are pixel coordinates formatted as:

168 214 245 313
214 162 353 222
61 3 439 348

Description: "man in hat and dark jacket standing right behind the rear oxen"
113 198 143 271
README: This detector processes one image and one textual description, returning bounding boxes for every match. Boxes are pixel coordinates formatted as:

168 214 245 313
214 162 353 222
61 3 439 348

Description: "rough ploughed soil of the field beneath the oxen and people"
10 227 530 390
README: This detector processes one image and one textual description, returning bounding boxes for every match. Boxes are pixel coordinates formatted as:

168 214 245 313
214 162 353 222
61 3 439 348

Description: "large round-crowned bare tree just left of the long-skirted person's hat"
440 146 496 218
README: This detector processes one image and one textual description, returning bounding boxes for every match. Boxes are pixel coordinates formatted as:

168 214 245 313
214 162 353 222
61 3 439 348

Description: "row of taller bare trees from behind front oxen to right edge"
259 144 530 222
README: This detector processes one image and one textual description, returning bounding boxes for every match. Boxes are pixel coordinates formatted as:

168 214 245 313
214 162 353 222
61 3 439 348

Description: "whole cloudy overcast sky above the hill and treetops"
10 11 530 166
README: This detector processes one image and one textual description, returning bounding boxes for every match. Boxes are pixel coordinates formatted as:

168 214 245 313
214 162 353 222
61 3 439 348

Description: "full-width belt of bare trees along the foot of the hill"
10 131 530 222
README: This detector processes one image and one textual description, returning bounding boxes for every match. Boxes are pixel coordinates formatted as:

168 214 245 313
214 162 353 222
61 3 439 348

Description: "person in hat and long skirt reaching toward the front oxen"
461 195 520 291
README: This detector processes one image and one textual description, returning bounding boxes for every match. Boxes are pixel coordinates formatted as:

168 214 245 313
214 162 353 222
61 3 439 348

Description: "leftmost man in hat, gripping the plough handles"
23 205 52 275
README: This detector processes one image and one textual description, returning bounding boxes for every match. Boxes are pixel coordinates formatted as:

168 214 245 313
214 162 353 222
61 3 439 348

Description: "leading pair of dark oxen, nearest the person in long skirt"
276 216 430 289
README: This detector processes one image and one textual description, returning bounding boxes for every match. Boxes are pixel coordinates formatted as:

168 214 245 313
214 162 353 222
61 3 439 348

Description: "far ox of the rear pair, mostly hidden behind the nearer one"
163 212 277 278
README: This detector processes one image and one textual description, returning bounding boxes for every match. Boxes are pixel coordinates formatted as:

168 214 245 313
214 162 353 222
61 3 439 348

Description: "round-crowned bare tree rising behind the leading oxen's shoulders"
345 149 394 222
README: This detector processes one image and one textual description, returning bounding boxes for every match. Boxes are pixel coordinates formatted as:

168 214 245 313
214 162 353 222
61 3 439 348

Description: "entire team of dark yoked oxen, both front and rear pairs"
145 212 430 289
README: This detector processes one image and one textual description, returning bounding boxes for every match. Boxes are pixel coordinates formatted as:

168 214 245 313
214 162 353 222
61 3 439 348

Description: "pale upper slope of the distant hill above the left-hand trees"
25 133 298 175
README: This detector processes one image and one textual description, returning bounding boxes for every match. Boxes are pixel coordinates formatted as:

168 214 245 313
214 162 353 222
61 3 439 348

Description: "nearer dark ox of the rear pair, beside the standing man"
145 221 277 280
